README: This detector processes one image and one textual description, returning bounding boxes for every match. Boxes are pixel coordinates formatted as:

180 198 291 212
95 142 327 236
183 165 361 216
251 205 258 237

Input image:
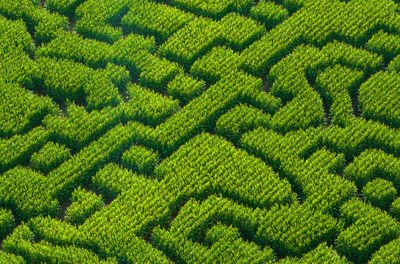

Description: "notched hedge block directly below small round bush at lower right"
336 198 400 263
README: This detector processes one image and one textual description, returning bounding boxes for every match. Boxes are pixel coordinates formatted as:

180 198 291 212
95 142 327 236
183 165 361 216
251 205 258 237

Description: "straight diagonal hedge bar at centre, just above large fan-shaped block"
151 73 262 155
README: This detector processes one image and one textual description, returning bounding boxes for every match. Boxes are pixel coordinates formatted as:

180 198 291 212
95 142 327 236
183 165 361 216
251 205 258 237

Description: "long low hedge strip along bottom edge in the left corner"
3 224 118 264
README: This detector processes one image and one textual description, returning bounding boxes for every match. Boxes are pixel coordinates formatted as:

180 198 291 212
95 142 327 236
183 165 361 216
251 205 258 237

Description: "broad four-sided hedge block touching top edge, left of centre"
121 0 194 42
